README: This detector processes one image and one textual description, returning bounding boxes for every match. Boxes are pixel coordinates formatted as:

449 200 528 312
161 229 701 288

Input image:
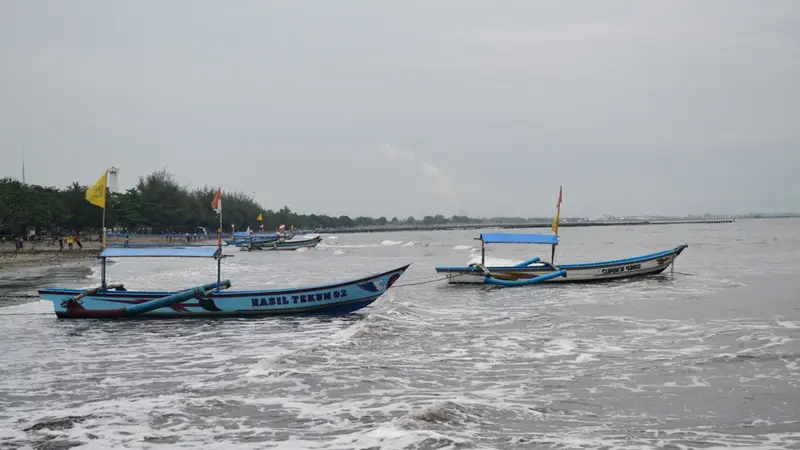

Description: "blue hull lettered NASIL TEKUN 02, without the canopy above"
39 265 409 318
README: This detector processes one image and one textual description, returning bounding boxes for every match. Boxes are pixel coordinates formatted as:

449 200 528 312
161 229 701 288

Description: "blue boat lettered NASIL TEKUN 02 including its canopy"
39 247 410 319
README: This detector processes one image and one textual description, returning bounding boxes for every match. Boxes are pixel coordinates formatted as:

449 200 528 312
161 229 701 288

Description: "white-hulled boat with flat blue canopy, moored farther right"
435 233 688 287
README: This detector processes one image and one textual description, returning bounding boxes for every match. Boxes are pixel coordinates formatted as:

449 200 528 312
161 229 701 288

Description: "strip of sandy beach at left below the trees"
0 237 222 271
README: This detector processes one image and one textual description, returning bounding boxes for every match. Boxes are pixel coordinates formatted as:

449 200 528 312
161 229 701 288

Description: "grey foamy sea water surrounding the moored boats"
0 220 800 449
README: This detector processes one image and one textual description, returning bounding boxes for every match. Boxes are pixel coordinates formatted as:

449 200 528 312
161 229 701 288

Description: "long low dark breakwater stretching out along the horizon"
309 218 736 234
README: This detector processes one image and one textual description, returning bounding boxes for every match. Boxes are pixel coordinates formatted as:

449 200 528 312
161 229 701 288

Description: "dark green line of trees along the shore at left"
0 170 556 236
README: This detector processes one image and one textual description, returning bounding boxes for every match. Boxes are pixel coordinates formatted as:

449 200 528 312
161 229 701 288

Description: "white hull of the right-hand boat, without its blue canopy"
436 245 687 284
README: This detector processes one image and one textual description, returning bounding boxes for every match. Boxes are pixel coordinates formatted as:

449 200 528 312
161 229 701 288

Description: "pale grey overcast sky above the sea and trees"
0 0 800 217
